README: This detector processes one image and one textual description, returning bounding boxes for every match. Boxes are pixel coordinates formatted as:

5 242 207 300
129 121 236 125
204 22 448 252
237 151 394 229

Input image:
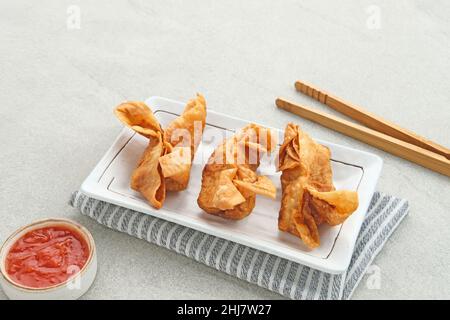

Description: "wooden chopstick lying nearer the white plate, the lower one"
276 98 450 177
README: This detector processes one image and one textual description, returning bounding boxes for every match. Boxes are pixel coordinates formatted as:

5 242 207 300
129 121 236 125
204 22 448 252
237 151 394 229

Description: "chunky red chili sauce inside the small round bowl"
6 226 89 288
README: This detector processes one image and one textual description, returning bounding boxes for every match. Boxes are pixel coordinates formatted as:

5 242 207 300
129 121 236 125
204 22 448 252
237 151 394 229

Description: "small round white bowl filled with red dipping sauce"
0 218 97 300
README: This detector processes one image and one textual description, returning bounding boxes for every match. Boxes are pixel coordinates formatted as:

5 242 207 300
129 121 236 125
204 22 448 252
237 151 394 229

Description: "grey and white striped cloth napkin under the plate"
70 191 409 299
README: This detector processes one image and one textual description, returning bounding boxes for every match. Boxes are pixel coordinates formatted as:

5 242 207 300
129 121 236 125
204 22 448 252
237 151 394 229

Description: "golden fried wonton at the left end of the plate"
114 94 206 209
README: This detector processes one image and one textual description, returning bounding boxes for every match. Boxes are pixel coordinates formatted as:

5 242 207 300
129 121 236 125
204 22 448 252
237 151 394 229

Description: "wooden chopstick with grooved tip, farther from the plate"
295 81 450 159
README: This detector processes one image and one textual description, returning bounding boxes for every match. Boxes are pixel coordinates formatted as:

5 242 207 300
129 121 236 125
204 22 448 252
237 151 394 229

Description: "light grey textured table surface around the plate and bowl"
0 0 450 299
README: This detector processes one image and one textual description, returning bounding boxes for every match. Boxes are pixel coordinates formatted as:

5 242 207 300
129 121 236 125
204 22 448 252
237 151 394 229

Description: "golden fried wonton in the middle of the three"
197 124 276 220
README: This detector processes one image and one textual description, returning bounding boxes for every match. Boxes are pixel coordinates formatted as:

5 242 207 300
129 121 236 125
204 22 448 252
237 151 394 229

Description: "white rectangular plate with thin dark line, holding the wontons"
81 97 382 273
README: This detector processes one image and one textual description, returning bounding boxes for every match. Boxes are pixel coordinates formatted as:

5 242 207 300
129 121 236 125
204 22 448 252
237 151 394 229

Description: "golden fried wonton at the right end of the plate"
278 123 358 248
